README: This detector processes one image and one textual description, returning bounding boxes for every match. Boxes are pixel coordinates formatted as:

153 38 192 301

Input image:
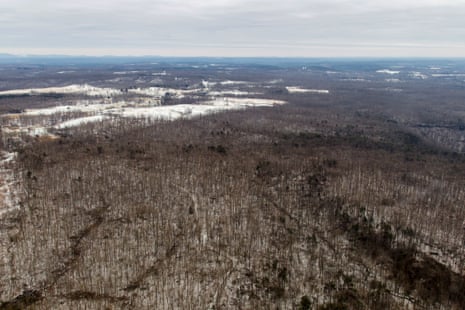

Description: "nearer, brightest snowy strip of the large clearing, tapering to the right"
3 95 286 136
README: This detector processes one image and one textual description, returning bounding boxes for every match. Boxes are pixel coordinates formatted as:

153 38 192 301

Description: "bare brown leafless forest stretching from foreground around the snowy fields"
0 59 465 310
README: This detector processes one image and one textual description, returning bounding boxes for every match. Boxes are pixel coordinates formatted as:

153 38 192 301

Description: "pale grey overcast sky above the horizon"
0 0 465 57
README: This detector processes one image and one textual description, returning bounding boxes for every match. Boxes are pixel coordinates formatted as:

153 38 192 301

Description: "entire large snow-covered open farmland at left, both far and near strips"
0 81 286 136
